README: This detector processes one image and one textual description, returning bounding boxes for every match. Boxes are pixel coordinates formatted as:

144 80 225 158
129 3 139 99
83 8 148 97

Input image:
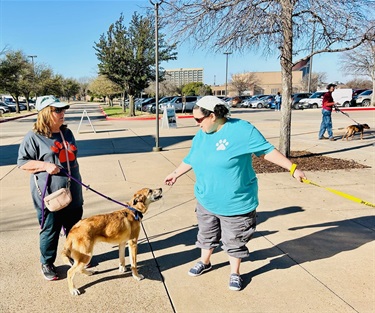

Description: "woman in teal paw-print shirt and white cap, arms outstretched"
165 96 305 290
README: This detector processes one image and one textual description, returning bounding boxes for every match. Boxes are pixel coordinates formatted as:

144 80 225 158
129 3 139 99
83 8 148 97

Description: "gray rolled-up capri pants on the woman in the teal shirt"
195 202 256 259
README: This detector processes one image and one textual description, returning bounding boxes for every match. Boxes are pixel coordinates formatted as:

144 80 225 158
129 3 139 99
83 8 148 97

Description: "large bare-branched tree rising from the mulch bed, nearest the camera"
163 0 375 156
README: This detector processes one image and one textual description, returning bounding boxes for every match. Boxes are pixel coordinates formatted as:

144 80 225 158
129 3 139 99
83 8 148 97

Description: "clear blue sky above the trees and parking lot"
0 0 350 84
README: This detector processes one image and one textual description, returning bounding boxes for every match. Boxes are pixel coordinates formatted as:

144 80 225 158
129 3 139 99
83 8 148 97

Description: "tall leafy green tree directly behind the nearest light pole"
94 13 177 116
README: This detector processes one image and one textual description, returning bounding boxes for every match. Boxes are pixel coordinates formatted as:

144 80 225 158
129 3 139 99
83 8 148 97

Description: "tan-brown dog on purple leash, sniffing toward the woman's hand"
61 188 162 296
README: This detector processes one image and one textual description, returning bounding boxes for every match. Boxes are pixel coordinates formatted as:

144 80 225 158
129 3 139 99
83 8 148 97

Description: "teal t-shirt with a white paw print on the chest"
183 119 274 216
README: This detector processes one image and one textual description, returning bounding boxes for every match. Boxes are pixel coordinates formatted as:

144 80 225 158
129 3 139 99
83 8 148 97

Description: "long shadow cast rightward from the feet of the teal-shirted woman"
244 215 375 282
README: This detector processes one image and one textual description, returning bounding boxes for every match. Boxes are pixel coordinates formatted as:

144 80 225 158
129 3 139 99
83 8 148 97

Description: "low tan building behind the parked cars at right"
211 70 304 97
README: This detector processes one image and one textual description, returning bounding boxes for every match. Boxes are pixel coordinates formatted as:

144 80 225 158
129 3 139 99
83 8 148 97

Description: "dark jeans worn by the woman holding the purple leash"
38 207 83 264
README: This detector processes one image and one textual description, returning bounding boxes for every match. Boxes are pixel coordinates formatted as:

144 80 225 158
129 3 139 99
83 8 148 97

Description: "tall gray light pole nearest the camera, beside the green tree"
150 0 164 152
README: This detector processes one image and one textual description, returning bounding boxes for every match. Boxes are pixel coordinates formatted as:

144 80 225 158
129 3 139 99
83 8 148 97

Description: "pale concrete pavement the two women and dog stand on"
0 104 375 313
